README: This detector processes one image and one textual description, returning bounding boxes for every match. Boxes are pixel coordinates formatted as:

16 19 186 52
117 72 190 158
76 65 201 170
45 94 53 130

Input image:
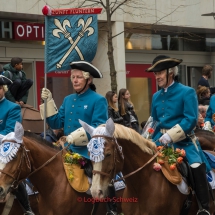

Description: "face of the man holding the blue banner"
71 70 89 92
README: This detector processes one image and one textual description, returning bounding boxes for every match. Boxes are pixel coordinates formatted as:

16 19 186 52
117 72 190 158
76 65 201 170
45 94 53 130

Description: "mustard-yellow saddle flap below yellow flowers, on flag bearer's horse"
62 152 90 193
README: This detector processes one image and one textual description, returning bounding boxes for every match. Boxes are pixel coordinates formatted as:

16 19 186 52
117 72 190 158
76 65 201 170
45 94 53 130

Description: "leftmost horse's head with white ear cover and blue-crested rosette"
0 122 30 200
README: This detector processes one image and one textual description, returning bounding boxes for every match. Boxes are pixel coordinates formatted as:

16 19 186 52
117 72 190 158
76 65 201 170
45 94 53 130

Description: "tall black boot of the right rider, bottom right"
191 163 210 215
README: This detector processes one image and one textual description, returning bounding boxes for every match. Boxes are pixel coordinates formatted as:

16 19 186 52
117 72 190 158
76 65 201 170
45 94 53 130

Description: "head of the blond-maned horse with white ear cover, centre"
79 118 123 198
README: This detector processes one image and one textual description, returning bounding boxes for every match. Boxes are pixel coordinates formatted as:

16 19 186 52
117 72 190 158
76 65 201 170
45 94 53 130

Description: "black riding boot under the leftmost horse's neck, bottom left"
13 182 35 215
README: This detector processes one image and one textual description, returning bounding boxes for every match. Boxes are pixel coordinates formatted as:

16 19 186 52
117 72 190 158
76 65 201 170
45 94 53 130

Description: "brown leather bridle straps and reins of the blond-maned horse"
92 135 160 182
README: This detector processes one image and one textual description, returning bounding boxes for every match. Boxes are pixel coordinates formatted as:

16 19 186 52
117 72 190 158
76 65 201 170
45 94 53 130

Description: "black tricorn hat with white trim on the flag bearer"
70 61 103 78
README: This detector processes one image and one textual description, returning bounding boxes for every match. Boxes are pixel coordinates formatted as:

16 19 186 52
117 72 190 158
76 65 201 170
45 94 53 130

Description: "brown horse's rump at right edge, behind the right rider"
195 129 215 151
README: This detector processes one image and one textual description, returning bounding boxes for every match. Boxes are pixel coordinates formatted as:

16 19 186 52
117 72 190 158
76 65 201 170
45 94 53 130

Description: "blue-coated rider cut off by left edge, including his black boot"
0 75 34 215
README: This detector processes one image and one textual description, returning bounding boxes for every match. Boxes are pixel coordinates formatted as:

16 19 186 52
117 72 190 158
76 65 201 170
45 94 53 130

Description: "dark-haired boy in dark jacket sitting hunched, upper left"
2 57 33 106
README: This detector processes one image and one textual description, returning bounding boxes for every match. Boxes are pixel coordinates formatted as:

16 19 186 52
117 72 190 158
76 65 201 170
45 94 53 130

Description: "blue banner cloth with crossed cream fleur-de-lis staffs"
45 14 98 73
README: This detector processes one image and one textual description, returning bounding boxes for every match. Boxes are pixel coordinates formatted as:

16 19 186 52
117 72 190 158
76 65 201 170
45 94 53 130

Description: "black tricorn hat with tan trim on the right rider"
146 55 183 72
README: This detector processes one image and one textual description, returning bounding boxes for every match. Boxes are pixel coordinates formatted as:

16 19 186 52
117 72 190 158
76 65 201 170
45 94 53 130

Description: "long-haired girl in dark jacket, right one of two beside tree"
118 88 140 133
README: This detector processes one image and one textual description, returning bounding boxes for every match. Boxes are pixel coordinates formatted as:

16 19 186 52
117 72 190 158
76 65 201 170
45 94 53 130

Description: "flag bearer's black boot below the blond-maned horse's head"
106 183 117 215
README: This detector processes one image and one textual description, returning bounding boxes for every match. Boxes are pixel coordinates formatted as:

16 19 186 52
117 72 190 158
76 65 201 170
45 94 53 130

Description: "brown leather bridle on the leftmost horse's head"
0 141 31 192
